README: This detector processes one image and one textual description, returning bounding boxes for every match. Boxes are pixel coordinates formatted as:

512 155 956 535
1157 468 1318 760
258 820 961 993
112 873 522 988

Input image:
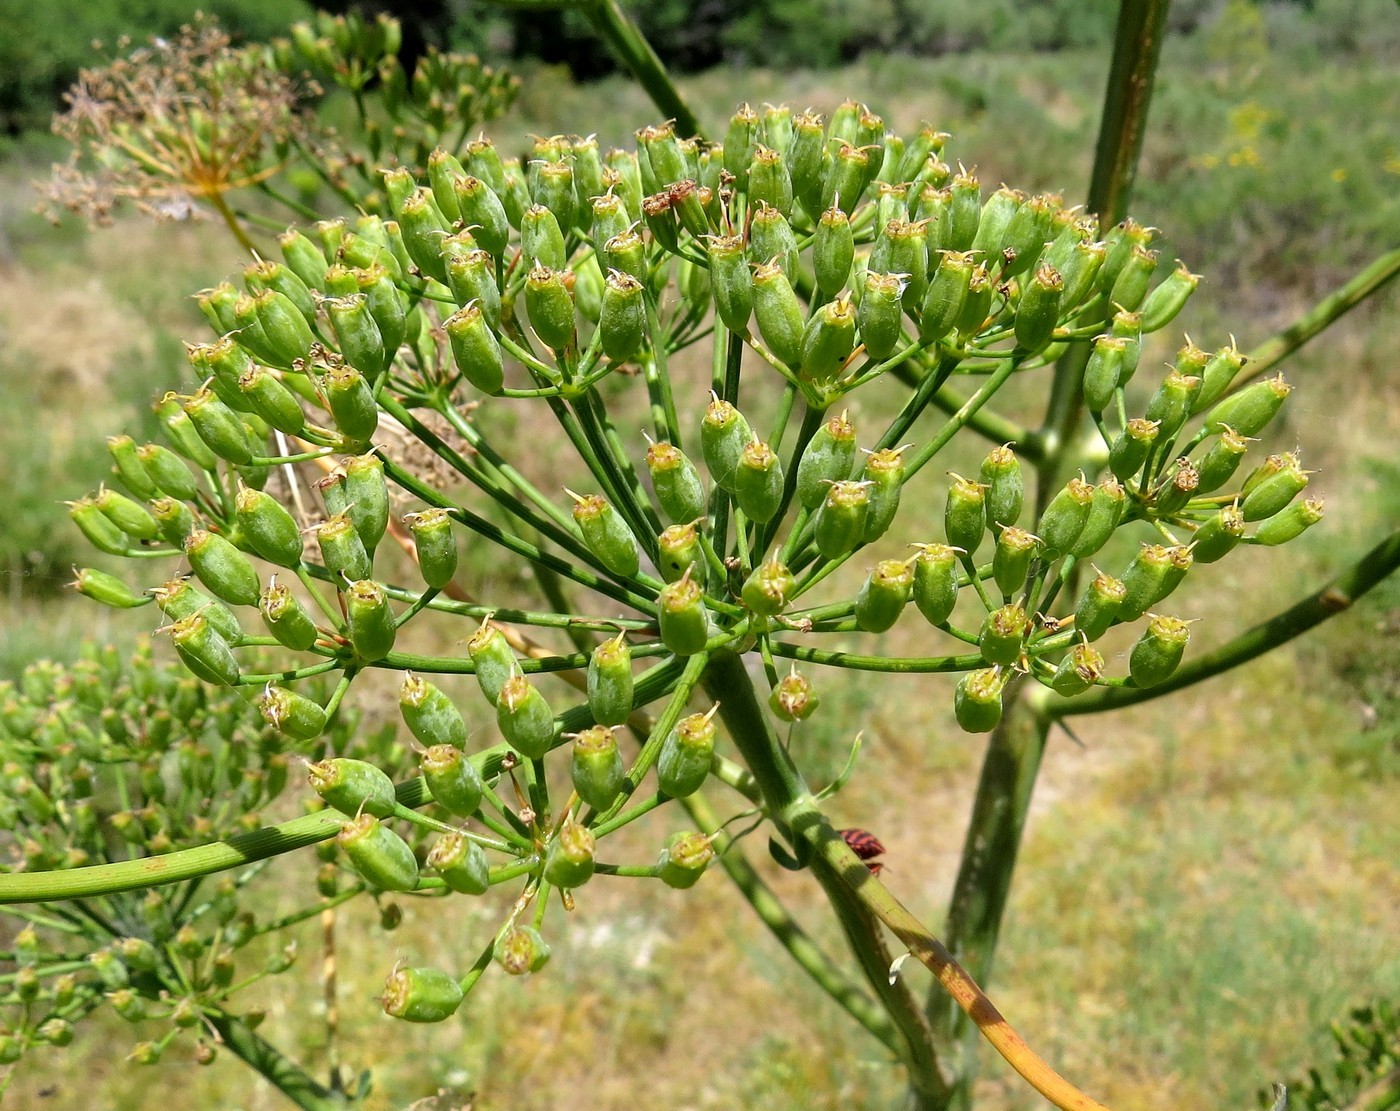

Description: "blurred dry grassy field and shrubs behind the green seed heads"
0 0 1400 1111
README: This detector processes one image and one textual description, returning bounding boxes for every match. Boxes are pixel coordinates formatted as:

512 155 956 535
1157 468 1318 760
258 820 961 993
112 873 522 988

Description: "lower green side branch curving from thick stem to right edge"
1046 530 1400 718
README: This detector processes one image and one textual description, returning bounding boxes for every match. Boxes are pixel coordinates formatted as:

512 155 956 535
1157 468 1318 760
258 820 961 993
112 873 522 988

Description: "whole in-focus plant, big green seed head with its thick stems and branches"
10 3 1397 1108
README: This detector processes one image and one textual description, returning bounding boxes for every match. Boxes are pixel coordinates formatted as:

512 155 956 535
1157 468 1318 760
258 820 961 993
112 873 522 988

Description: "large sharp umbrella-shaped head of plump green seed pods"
71 104 1322 1021
